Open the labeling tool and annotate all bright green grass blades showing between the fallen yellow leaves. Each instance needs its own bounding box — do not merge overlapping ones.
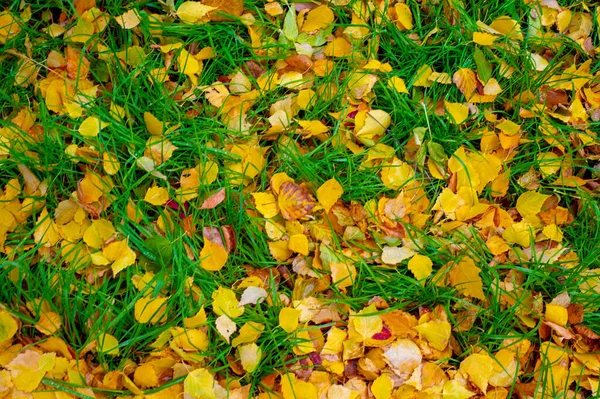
[0,0,600,395]
